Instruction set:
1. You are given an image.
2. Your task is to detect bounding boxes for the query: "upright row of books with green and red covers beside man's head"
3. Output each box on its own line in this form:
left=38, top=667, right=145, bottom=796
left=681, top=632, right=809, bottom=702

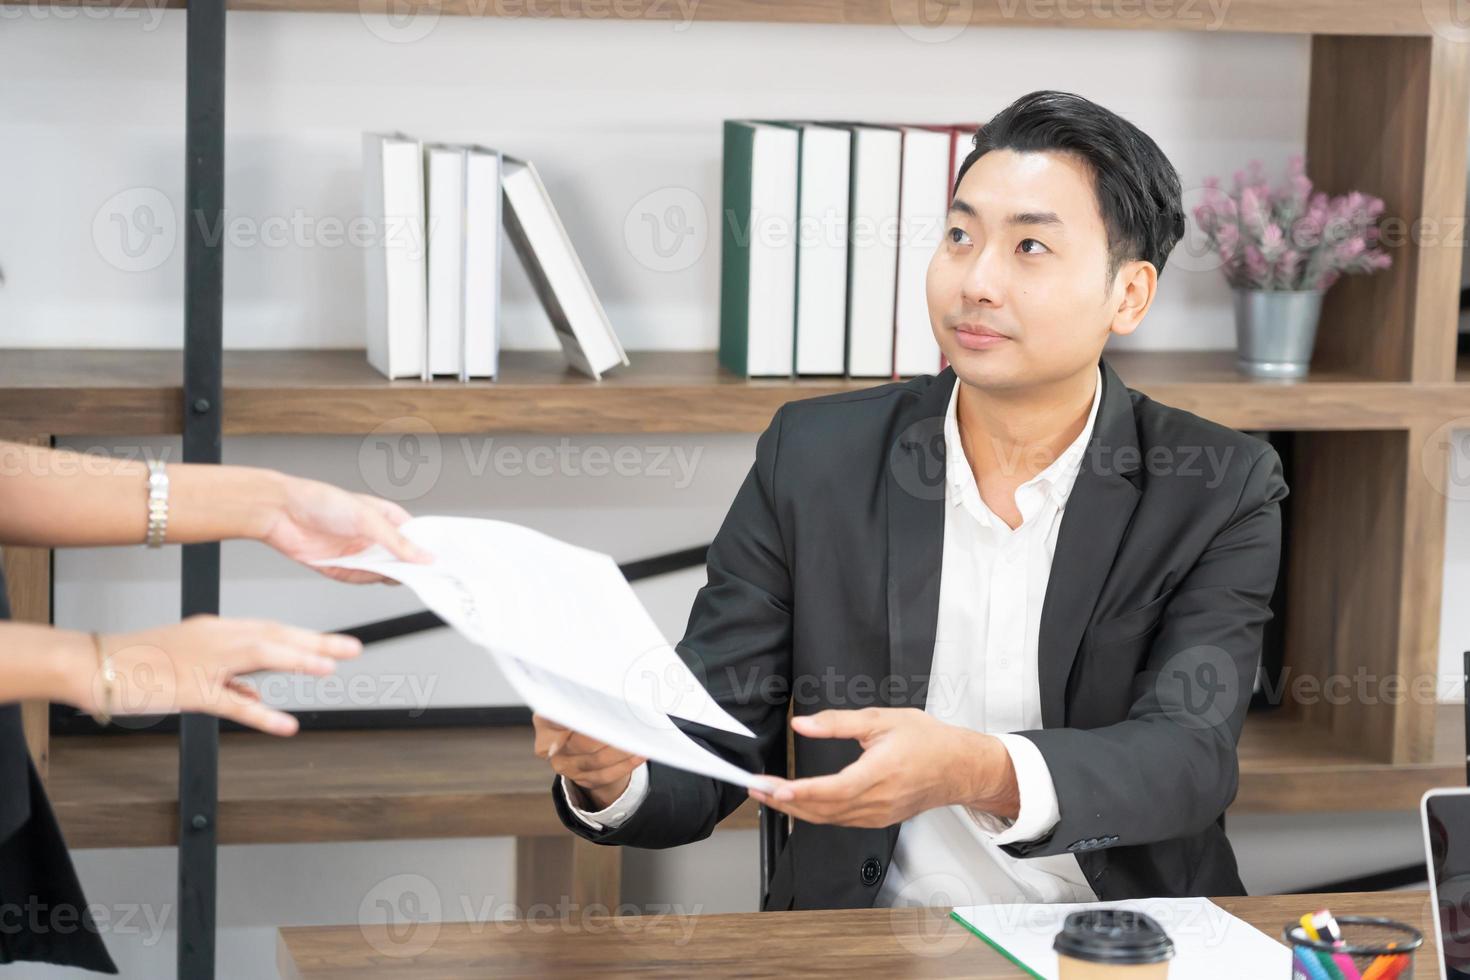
left=720, top=119, right=978, bottom=378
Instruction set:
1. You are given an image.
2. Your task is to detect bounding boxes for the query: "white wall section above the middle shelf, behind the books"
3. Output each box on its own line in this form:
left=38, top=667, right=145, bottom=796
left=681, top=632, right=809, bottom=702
left=0, top=7, right=1307, bottom=350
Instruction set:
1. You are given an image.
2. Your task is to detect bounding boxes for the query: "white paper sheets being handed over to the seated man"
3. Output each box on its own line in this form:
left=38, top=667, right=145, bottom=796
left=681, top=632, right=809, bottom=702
left=313, top=517, right=764, bottom=788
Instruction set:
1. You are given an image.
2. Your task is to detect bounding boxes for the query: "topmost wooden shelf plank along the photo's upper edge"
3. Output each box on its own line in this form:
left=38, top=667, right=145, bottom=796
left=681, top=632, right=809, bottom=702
left=3, top=0, right=1454, bottom=35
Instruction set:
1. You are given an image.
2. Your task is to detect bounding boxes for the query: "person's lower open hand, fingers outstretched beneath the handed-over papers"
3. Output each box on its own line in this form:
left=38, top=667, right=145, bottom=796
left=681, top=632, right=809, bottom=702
left=68, top=616, right=362, bottom=735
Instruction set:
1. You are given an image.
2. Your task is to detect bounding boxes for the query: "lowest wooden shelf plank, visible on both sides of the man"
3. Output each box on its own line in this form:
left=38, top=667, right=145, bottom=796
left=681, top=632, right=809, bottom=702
left=49, top=705, right=1466, bottom=848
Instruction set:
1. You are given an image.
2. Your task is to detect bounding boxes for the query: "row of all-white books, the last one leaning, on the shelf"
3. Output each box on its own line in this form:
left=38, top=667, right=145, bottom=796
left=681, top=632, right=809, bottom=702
left=363, top=132, right=628, bottom=381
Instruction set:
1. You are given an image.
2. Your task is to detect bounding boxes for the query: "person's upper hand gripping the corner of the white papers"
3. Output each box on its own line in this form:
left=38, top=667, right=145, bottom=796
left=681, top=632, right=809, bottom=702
left=256, top=473, right=434, bottom=582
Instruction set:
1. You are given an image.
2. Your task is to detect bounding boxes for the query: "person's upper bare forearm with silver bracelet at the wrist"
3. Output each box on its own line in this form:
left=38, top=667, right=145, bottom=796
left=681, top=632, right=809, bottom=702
left=0, top=442, right=282, bottom=548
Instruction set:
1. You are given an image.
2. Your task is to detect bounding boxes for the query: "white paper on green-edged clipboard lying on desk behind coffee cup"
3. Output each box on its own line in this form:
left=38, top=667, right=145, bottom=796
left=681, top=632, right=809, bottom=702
left=954, top=898, right=1291, bottom=980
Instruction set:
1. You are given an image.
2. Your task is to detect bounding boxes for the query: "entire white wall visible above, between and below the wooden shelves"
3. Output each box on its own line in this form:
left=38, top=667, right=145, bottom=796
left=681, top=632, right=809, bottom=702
left=0, top=7, right=1470, bottom=977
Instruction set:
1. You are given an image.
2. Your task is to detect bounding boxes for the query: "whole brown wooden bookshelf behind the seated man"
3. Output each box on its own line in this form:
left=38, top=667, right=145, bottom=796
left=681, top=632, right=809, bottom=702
left=0, top=0, right=1470, bottom=922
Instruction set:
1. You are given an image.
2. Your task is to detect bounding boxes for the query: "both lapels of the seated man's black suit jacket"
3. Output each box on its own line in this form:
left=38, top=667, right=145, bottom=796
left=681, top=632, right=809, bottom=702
left=885, top=360, right=1141, bottom=729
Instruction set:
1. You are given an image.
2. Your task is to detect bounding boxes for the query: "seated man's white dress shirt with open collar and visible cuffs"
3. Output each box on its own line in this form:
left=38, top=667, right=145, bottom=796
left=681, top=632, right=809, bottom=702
left=562, top=367, right=1103, bottom=905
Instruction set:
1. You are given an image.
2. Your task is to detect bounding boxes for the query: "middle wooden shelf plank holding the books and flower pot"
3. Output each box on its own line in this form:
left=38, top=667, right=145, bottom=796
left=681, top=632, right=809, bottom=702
left=0, top=350, right=1470, bottom=436
